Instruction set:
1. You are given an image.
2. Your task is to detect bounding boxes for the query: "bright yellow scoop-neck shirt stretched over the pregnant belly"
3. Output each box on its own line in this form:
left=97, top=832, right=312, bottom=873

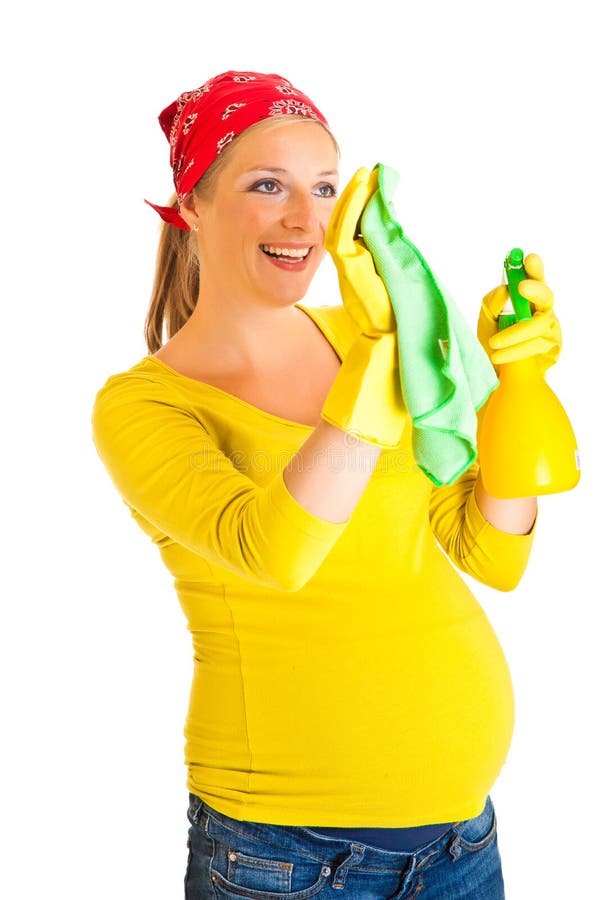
left=92, top=306, right=532, bottom=828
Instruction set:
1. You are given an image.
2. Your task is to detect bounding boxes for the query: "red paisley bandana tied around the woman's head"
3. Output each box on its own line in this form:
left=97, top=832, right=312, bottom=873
left=146, top=72, right=328, bottom=231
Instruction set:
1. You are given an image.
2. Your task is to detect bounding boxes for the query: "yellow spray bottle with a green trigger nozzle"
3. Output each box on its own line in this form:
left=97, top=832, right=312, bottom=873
left=478, top=248, right=580, bottom=499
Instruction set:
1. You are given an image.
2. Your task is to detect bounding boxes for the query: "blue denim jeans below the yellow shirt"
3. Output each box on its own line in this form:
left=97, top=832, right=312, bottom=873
left=184, top=795, right=504, bottom=900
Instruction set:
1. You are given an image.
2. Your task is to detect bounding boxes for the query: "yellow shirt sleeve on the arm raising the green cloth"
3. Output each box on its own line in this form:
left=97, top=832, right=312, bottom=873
left=92, top=373, right=347, bottom=591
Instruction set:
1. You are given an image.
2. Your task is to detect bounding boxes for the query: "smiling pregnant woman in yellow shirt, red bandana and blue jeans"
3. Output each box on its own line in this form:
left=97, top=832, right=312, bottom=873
left=93, top=72, right=552, bottom=900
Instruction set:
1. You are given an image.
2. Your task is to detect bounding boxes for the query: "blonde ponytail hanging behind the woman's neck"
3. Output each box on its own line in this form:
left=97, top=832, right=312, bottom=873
left=144, top=194, right=199, bottom=353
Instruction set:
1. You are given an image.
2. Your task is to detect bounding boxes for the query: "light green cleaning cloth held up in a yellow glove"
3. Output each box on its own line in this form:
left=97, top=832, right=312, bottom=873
left=360, top=163, right=498, bottom=485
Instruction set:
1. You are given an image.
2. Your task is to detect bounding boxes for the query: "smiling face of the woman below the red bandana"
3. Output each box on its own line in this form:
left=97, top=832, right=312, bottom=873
left=185, top=119, right=338, bottom=306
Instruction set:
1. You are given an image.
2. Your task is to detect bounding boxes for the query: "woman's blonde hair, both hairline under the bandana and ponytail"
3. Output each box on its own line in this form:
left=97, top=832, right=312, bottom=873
left=144, top=116, right=339, bottom=353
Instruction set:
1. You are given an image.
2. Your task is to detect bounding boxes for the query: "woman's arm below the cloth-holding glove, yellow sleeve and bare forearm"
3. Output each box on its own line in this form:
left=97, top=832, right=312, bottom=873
left=92, top=372, right=390, bottom=591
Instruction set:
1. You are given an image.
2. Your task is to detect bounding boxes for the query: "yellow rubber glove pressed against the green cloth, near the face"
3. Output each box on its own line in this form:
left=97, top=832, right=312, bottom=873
left=322, top=168, right=407, bottom=449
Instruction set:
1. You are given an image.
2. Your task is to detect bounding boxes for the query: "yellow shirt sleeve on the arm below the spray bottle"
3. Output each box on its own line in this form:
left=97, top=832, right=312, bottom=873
left=430, top=464, right=535, bottom=591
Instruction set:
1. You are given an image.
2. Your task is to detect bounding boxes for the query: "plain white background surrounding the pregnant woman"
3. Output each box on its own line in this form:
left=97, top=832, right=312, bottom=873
left=0, top=0, right=610, bottom=900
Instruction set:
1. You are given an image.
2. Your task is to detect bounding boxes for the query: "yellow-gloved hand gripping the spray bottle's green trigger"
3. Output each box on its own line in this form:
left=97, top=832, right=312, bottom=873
left=477, top=253, right=561, bottom=371
